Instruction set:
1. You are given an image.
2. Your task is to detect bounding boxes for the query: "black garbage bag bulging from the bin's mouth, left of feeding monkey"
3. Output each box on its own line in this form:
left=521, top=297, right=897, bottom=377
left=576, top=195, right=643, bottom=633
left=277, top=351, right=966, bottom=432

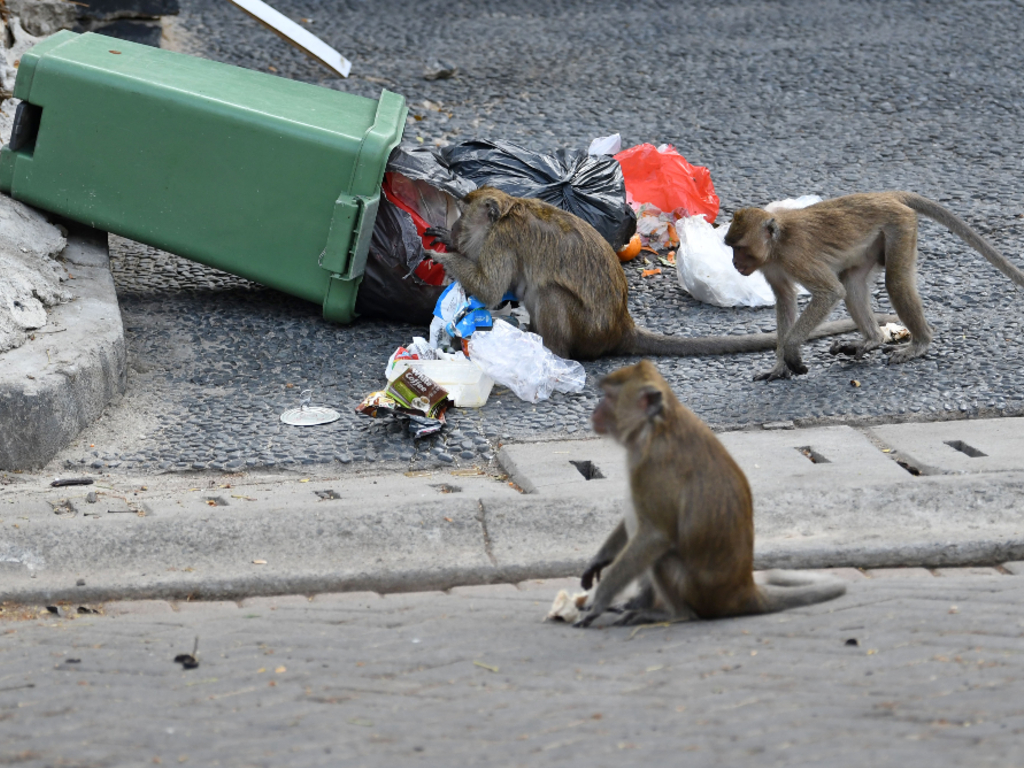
left=355, top=198, right=444, bottom=326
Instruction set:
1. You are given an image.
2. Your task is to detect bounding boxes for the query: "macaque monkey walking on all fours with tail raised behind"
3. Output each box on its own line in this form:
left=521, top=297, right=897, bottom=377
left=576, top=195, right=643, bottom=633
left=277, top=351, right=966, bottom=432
left=725, top=191, right=1024, bottom=381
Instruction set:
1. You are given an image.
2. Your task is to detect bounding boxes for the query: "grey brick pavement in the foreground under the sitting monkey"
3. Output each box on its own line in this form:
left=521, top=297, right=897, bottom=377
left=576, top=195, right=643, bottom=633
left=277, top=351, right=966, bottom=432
left=0, top=566, right=1024, bottom=768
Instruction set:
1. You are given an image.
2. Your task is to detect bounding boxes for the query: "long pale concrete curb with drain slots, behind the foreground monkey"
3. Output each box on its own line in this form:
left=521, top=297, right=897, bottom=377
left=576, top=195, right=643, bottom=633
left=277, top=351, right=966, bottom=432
left=6, top=419, right=1024, bottom=603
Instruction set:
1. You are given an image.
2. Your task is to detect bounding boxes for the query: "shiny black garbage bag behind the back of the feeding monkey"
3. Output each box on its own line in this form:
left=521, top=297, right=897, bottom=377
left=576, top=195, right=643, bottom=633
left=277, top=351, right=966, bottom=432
left=439, top=139, right=637, bottom=251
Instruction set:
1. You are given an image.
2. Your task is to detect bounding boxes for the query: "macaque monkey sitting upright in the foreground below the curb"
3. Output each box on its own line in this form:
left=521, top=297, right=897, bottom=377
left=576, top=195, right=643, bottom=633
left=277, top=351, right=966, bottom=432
left=575, top=360, right=846, bottom=627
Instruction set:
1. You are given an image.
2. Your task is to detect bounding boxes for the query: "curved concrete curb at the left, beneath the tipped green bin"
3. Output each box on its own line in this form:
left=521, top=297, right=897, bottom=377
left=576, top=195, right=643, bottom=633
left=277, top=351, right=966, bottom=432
left=0, top=228, right=126, bottom=470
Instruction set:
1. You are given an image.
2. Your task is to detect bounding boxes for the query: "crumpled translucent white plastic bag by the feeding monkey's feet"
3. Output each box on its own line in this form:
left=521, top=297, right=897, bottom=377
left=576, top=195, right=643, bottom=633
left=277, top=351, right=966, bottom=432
left=469, top=321, right=587, bottom=402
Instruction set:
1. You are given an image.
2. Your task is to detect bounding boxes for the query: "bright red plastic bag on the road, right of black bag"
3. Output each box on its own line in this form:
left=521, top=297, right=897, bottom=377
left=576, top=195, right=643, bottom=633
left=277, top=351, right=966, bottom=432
left=615, top=144, right=719, bottom=223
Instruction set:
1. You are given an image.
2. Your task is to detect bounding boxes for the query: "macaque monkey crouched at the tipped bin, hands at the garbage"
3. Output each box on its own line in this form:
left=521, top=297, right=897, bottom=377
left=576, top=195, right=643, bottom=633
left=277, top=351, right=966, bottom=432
left=427, top=186, right=886, bottom=359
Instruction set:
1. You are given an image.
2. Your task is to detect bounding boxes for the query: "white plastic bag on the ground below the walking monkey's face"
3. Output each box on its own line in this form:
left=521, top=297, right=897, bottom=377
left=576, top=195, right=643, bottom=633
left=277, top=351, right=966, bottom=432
left=676, top=216, right=775, bottom=306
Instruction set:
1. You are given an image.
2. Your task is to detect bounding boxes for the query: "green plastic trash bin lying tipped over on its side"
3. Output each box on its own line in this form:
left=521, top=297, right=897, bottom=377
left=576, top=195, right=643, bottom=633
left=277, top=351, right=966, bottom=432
left=0, top=32, right=408, bottom=323
